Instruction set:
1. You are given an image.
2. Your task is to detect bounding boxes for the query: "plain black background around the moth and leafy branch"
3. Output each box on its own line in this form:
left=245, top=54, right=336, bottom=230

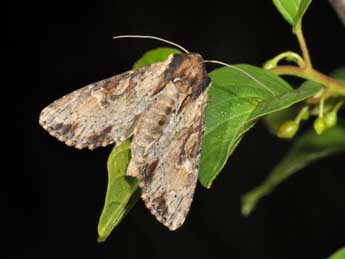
left=8, top=0, right=345, bottom=259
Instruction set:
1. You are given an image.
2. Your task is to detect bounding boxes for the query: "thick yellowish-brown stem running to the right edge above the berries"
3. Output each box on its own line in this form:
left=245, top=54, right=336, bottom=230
left=271, top=66, right=345, bottom=96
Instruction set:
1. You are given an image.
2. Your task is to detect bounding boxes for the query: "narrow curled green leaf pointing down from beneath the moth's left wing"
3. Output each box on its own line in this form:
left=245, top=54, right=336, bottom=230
left=98, top=140, right=140, bottom=242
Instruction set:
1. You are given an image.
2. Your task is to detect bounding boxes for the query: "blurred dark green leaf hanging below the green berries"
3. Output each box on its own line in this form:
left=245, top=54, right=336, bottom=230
left=242, top=125, right=345, bottom=215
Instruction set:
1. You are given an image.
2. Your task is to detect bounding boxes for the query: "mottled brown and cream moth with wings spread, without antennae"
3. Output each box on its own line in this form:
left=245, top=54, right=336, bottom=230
left=39, top=35, right=211, bottom=230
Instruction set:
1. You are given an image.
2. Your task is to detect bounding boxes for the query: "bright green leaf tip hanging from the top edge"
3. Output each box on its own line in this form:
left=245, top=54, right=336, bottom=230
left=273, top=0, right=311, bottom=28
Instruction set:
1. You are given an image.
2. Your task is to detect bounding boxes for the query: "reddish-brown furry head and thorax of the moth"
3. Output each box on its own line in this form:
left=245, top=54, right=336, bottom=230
left=168, top=53, right=211, bottom=97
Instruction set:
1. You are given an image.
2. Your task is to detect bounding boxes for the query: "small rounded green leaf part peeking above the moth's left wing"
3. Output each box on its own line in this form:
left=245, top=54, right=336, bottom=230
left=133, top=48, right=181, bottom=68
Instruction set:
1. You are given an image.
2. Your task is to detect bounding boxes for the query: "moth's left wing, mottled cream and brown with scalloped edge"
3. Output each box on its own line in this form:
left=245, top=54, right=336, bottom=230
left=39, top=57, right=172, bottom=149
